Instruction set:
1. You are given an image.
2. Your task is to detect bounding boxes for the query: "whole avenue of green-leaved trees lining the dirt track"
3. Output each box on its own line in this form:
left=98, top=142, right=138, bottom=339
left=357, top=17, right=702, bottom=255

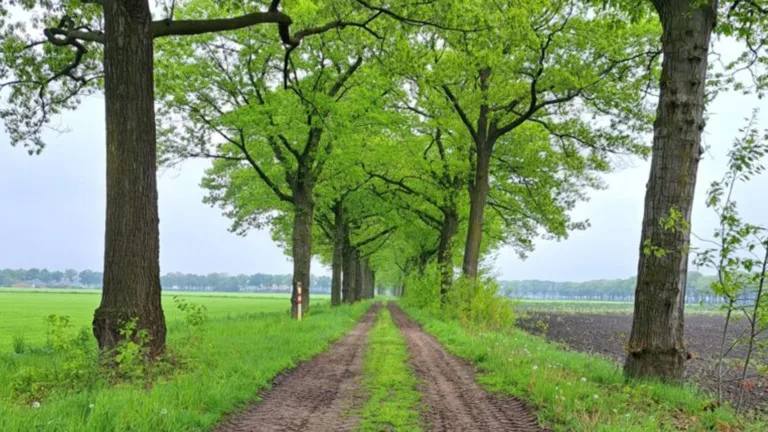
left=0, top=0, right=768, bottom=381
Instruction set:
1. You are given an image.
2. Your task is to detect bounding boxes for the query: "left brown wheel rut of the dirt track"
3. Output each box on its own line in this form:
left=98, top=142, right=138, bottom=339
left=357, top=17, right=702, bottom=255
left=216, top=304, right=381, bottom=432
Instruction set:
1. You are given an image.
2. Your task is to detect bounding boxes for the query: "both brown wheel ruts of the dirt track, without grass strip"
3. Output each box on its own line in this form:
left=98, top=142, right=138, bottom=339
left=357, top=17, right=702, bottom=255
left=217, top=303, right=542, bottom=432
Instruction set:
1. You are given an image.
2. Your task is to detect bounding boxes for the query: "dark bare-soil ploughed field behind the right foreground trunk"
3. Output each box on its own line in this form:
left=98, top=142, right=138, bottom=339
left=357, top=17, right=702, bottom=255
left=518, top=312, right=768, bottom=412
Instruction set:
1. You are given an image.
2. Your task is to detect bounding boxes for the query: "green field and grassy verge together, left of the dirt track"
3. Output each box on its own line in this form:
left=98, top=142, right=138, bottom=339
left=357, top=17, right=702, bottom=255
left=0, top=291, right=370, bottom=432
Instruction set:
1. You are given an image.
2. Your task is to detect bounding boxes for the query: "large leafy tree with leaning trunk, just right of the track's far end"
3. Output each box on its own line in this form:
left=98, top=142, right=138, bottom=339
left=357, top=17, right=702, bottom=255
left=380, top=1, right=656, bottom=278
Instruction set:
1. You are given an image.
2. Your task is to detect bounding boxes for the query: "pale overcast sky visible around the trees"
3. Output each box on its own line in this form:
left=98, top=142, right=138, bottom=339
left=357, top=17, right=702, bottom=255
left=0, top=44, right=768, bottom=281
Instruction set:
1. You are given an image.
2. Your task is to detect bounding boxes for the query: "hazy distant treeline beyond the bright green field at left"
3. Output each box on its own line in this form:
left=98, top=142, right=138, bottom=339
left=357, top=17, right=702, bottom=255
left=0, top=268, right=331, bottom=293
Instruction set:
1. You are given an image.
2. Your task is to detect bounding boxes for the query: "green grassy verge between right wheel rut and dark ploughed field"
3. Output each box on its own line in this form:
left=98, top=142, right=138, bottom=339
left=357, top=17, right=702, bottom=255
left=405, top=306, right=768, bottom=432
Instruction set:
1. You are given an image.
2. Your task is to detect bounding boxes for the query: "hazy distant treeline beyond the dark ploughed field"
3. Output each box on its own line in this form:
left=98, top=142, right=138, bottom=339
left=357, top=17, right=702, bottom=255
left=499, top=272, right=720, bottom=303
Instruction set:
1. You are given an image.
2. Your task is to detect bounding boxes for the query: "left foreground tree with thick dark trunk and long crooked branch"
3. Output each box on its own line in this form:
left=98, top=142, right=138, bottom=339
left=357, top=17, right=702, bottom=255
left=0, top=0, right=402, bottom=356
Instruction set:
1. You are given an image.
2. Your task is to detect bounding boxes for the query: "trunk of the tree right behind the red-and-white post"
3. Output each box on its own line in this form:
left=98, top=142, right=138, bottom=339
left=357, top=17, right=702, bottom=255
left=291, top=186, right=314, bottom=317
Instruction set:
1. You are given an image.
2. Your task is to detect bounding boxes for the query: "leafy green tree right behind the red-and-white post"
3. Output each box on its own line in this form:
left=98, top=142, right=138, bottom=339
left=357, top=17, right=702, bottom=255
left=154, top=6, right=390, bottom=314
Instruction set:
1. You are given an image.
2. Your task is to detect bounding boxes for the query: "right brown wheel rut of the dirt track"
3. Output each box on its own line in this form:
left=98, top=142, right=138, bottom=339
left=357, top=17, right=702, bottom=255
left=389, top=303, right=542, bottom=432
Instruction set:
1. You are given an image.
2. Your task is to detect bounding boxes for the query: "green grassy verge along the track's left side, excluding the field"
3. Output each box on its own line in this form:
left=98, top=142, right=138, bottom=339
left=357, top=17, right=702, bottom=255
left=0, top=296, right=370, bottom=432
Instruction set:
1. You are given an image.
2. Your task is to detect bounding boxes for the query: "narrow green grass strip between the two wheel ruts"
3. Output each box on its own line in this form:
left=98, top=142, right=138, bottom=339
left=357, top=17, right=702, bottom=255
left=360, top=307, right=421, bottom=431
